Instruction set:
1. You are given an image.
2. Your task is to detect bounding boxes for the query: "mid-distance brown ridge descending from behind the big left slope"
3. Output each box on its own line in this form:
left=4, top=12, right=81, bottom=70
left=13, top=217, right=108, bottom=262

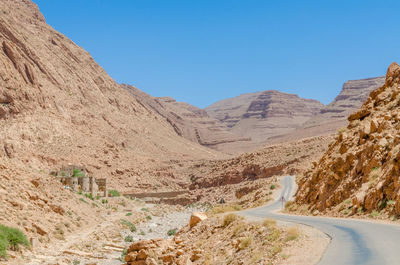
left=122, top=85, right=250, bottom=149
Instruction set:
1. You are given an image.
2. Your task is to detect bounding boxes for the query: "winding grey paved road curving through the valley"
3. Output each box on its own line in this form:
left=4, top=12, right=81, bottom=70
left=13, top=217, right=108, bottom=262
left=242, top=176, right=400, bottom=265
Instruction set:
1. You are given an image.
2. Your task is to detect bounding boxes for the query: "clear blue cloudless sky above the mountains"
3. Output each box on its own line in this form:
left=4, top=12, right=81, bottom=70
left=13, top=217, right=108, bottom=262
left=34, top=0, right=400, bottom=107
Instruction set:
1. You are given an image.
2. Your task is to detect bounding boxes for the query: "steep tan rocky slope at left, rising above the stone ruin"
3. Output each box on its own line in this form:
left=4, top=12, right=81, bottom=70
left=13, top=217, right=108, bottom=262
left=0, top=0, right=222, bottom=191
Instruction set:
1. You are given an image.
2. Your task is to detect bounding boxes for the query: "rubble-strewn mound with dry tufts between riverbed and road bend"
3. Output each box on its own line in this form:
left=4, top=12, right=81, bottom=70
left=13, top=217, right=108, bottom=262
left=125, top=213, right=328, bottom=265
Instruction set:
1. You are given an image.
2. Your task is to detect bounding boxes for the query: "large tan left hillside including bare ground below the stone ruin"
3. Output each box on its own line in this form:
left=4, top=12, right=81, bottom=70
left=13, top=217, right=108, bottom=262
left=0, top=0, right=227, bottom=250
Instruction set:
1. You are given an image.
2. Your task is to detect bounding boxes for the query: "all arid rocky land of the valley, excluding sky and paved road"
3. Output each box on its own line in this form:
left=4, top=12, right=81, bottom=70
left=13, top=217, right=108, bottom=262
left=0, top=0, right=400, bottom=265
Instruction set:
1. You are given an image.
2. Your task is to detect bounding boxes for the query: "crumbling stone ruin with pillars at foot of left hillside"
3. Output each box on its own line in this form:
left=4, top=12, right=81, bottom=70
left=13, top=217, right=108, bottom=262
left=54, top=165, right=107, bottom=197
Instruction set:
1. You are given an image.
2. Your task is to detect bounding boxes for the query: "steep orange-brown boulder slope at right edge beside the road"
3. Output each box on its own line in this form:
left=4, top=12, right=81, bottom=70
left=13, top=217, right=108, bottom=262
left=296, top=63, right=400, bottom=215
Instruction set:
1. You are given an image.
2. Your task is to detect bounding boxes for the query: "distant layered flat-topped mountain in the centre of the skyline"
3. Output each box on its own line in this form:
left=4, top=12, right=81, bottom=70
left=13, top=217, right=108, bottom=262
left=205, top=90, right=324, bottom=143
